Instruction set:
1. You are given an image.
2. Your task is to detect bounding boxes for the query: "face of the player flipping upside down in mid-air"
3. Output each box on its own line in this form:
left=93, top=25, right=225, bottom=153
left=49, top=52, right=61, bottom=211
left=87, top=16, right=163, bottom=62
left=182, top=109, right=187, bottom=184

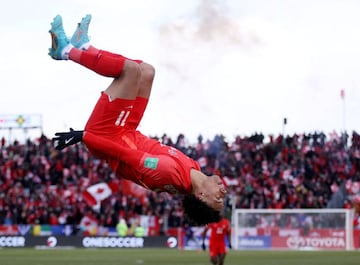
left=204, top=175, right=226, bottom=211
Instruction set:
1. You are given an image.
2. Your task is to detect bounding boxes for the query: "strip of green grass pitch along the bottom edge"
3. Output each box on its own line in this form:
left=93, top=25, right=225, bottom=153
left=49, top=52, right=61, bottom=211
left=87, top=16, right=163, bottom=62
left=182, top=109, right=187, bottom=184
left=0, top=248, right=360, bottom=265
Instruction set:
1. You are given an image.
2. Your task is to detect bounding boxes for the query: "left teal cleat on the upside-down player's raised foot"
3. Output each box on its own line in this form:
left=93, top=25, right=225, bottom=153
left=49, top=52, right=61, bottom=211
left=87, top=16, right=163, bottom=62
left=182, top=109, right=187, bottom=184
left=49, top=15, right=69, bottom=60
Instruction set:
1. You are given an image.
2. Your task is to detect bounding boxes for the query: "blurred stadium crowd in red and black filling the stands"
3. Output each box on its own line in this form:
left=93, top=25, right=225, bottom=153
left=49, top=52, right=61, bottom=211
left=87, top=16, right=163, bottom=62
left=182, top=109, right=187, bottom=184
left=0, top=132, right=360, bottom=234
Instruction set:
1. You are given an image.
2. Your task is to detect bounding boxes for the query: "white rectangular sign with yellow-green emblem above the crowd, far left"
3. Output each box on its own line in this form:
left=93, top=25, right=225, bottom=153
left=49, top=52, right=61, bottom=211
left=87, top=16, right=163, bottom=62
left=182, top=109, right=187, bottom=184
left=0, top=114, right=42, bottom=129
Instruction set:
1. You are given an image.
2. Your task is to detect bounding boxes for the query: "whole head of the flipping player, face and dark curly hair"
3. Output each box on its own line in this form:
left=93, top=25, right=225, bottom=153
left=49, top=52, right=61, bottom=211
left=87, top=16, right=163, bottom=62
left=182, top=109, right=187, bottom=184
left=183, top=175, right=226, bottom=225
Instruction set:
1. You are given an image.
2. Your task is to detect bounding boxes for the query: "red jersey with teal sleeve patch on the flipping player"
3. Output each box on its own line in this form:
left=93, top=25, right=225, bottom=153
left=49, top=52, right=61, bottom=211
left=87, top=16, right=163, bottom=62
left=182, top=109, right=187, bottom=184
left=83, top=131, right=200, bottom=194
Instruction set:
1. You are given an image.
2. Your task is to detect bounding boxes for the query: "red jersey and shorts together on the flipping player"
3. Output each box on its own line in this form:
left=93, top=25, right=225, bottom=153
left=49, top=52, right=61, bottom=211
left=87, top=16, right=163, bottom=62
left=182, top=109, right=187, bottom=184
left=83, top=92, right=200, bottom=194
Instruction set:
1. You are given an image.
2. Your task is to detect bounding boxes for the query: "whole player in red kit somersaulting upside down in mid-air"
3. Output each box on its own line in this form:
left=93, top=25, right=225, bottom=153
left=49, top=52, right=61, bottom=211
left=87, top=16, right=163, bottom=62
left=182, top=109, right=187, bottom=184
left=49, top=15, right=226, bottom=225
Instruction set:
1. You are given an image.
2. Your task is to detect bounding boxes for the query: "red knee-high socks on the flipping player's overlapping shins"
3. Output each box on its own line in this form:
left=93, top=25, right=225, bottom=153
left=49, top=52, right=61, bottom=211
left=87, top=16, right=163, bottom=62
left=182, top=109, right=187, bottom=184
left=69, top=48, right=127, bottom=77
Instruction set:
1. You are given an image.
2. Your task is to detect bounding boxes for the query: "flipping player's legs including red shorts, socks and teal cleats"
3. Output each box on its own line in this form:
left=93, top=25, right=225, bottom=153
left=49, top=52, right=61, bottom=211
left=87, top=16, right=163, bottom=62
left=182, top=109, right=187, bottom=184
left=49, top=15, right=155, bottom=135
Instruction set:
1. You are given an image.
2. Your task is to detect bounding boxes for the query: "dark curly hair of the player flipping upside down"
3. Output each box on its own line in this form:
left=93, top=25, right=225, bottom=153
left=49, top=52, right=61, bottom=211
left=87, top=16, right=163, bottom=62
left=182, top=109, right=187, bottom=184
left=182, top=194, right=221, bottom=226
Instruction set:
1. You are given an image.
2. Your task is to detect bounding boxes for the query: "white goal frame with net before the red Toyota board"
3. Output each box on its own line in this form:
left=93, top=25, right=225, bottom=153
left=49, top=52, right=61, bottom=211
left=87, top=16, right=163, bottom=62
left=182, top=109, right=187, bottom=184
left=232, top=209, right=354, bottom=250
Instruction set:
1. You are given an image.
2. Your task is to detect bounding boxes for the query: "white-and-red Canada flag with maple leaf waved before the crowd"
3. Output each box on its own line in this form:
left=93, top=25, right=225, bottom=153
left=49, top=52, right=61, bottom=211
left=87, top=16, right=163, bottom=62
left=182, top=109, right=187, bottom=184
left=82, top=182, right=119, bottom=210
